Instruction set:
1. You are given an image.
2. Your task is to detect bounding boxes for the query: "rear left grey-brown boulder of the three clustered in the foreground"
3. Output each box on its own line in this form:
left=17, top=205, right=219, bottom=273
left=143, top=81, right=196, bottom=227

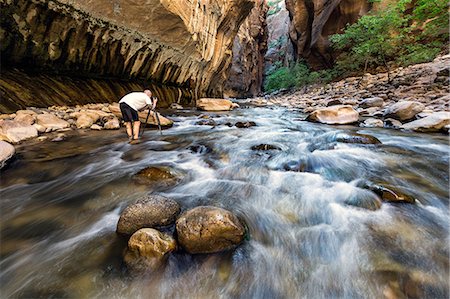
left=117, top=195, right=180, bottom=235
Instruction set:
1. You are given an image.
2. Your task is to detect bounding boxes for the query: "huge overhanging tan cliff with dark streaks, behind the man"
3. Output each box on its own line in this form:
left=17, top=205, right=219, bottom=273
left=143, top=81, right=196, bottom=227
left=0, top=0, right=253, bottom=112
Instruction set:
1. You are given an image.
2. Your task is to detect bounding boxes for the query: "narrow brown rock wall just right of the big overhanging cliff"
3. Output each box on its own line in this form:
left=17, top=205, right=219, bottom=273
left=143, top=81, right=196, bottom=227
left=224, top=0, right=268, bottom=98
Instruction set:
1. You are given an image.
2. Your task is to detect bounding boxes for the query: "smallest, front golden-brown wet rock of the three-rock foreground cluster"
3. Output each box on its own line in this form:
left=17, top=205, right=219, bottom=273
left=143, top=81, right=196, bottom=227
left=124, top=228, right=177, bottom=272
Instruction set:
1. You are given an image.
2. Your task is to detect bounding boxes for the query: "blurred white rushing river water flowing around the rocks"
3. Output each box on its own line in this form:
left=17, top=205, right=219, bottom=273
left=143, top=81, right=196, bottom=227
left=0, top=107, right=450, bottom=298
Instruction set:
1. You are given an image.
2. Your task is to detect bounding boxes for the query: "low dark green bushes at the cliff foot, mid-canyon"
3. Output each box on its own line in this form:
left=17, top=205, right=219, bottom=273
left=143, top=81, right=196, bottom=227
left=264, top=61, right=337, bottom=92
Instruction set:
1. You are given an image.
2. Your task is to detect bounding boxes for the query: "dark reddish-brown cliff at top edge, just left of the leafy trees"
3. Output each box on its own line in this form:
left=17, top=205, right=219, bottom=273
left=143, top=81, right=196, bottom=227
left=286, top=0, right=372, bottom=69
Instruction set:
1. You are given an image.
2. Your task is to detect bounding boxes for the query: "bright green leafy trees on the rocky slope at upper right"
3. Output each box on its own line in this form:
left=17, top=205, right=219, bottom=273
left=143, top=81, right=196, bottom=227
left=330, top=0, right=448, bottom=72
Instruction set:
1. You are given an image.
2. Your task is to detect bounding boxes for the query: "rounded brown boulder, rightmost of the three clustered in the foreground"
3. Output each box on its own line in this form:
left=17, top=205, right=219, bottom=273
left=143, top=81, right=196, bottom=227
left=176, top=206, right=245, bottom=253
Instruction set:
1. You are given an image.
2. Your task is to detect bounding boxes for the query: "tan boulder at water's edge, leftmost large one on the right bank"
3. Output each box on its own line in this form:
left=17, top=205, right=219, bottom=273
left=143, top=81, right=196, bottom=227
left=306, top=105, right=359, bottom=125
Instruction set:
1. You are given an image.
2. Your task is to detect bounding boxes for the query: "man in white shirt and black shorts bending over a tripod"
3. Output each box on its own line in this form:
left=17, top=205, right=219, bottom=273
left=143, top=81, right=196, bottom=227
left=119, top=89, right=158, bottom=143
